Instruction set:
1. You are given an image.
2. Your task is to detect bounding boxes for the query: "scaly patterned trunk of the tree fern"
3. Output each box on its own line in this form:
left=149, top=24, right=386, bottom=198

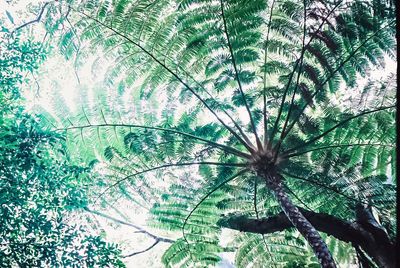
left=266, top=174, right=336, bottom=268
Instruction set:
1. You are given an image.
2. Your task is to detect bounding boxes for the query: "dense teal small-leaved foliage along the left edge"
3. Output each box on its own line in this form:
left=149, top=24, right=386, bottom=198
left=0, top=27, right=124, bottom=267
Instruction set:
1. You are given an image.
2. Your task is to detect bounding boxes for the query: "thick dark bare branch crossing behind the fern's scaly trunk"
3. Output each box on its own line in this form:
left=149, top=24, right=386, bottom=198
left=217, top=208, right=396, bottom=267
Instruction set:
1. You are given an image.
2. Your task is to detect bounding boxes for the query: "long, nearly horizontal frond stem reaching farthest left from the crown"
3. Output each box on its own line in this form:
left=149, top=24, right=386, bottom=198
left=56, top=124, right=251, bottom=159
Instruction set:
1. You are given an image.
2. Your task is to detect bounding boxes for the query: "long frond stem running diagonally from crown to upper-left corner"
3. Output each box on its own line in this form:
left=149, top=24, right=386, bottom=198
left=75, top=7, right=253, bottom=152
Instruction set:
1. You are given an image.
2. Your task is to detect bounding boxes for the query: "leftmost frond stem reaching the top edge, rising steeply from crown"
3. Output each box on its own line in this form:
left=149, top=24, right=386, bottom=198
left=220, top=0, right=262, bottom=150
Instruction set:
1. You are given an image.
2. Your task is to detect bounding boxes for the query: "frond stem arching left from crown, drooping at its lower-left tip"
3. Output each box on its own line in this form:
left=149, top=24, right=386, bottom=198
left=95, top=162, right=247, bottom=202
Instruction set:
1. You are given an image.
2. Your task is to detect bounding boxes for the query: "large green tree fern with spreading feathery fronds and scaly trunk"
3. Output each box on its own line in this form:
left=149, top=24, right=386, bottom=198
left=36, top=0, right=395, bottom=267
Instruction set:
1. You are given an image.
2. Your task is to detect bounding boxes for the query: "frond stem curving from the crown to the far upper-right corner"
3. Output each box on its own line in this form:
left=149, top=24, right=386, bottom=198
left=282, top=21, right=395, bottom=142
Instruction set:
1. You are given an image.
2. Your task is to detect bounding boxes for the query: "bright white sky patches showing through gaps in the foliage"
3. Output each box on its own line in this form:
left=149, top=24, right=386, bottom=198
left=0, top=0, right=396, bottom=267
